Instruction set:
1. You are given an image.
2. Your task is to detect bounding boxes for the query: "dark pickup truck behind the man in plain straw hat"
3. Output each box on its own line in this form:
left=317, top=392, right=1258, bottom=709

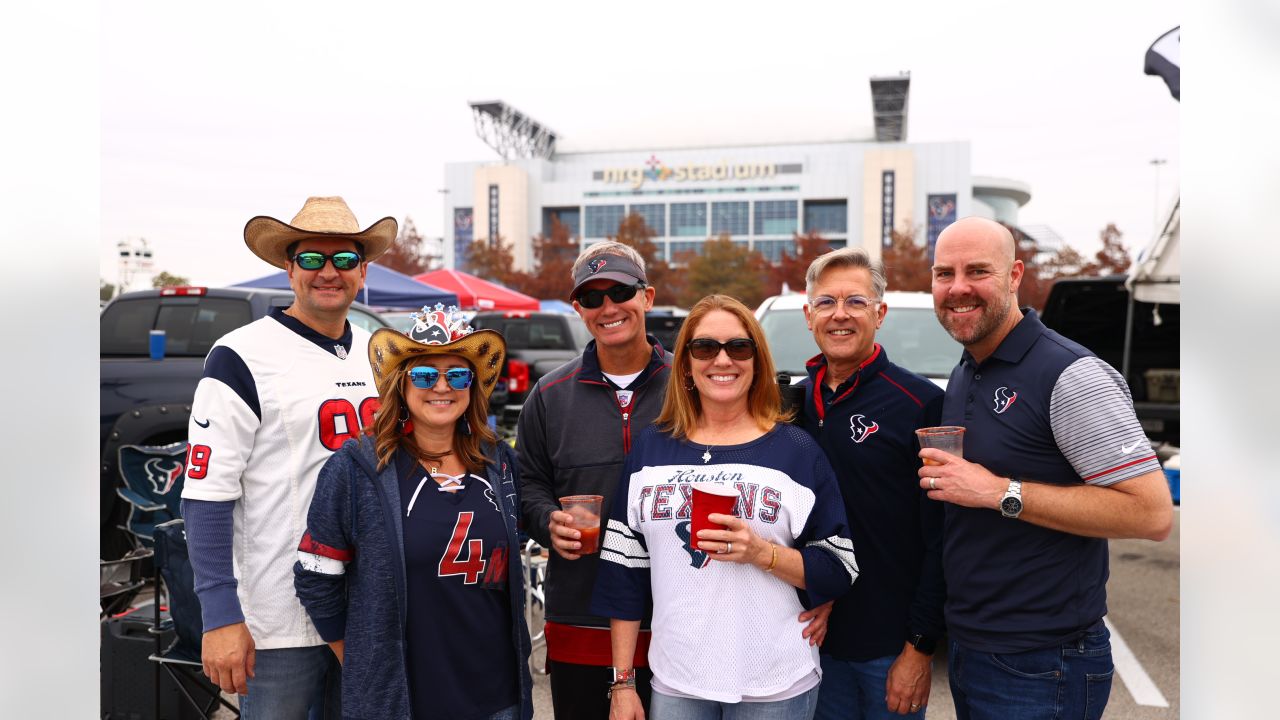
left=99, top=287, right=387, bottom=559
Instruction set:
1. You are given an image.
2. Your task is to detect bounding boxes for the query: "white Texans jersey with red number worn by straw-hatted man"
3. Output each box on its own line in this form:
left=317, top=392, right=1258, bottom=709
left=182, top=313, right=379, bottom=650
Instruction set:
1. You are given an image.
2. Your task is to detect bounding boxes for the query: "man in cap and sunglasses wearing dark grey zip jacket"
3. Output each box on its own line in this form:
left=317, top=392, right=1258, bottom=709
left=516, top=241, right=672, bottom=720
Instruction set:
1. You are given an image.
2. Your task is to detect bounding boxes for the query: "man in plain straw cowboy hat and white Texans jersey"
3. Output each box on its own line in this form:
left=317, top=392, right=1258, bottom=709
left=182, top=197, right=397, bottom=720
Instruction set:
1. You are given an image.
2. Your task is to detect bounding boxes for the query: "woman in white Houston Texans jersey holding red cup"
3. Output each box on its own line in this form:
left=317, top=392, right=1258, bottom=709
left=591, top=295, right=858, bottom=720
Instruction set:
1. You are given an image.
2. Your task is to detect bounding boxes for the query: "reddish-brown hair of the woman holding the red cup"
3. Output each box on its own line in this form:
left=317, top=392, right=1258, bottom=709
left=654, top=295, right=791, bottom=438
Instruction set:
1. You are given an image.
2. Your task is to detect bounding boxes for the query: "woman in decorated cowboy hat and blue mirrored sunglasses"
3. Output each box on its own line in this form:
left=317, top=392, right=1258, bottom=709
left=294, top=305, right=532, bottom=720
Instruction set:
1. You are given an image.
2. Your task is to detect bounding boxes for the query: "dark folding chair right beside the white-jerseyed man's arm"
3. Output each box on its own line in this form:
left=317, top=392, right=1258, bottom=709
left=148, top=519, right=239, bottom=720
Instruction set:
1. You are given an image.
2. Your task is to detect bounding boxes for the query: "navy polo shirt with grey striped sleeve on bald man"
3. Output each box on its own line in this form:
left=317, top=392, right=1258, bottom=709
left=942, top=309, right=1160, bottom=652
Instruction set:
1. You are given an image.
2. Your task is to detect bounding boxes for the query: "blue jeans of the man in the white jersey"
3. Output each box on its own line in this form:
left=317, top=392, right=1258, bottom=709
left=239, top=644, right=342, bottom=720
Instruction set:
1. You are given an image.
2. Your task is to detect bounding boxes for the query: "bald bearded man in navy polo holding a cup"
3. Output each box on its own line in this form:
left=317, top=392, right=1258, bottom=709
left=920, top=218, right=1172, bottom=720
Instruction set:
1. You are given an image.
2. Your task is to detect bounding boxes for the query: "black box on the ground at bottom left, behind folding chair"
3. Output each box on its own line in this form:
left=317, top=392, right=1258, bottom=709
left=100, top=605, right=220, bottom=720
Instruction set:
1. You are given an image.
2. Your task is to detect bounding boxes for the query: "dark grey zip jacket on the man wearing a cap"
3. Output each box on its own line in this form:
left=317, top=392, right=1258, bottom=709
left=516, top=336, right=672, bottom=628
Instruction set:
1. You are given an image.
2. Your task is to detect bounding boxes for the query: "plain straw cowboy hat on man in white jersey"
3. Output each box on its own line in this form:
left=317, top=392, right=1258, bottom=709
left=244, top=197, right=398, bottom=268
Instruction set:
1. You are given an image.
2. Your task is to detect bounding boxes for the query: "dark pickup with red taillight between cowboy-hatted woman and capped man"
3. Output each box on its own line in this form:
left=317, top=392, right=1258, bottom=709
left=471, top=310, right=591, bottom=425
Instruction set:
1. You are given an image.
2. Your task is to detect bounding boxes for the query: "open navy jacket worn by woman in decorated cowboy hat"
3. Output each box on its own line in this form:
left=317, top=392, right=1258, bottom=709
left=293, top=436, right=534, bottom=720
